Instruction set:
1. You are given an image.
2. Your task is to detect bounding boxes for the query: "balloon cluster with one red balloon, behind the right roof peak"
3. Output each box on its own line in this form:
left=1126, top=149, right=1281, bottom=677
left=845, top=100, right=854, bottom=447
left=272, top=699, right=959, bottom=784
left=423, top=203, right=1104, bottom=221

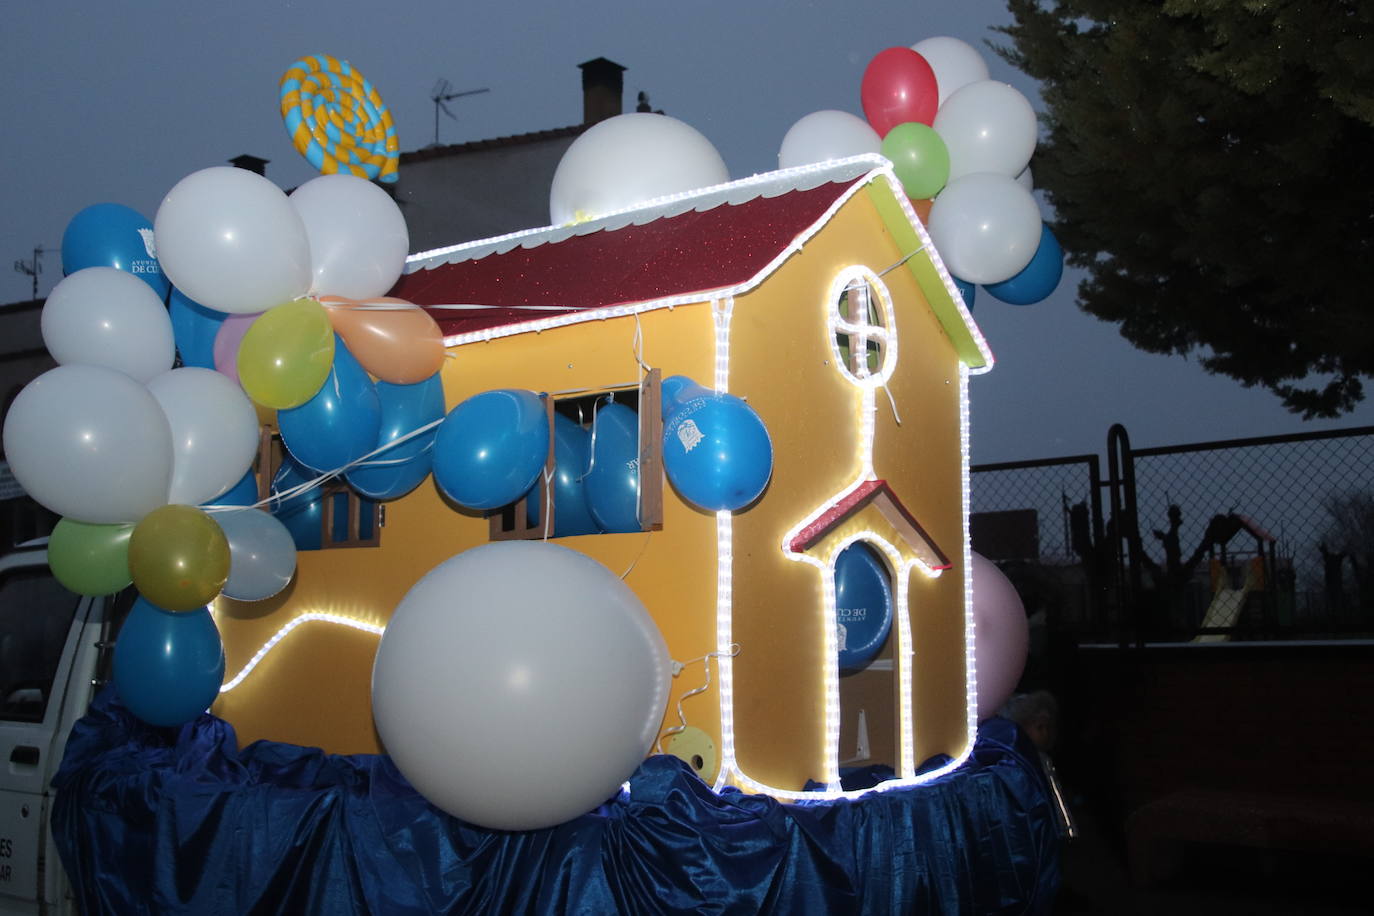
left=779, top=36, right=1063, bottom=305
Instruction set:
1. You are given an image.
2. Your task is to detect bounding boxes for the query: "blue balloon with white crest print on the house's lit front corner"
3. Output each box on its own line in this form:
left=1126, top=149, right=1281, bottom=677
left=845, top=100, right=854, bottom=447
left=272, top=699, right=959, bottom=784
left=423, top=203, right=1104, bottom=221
left=662, top=375, right=772, bottom=511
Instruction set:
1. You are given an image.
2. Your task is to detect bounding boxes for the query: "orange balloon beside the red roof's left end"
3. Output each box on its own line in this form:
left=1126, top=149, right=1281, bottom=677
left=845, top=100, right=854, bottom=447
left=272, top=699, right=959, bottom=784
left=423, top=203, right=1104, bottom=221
left=320, top=295, right=444, bottom=385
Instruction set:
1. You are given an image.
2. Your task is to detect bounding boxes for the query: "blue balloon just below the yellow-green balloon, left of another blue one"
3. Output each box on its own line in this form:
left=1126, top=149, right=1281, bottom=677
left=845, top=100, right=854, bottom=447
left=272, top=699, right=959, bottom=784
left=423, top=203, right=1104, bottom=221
left=276, top=335, right=382, bottom=472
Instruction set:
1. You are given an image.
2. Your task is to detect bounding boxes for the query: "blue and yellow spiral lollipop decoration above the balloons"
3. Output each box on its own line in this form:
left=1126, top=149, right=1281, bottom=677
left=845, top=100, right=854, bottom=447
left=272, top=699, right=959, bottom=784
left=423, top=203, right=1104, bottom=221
left=282, top=54, right=400, bottom=183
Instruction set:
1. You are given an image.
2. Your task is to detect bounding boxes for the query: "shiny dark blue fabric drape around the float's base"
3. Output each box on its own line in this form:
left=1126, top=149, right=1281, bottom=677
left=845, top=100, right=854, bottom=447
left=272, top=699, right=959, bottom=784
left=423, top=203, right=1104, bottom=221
left=54, top=691, right=1059, bottom=916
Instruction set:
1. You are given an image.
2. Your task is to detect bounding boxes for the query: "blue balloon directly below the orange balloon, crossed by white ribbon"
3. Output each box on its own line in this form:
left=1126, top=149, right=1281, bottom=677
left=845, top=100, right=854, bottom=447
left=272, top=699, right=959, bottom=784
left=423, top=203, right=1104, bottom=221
left=344, top=372, right=444, bottom=500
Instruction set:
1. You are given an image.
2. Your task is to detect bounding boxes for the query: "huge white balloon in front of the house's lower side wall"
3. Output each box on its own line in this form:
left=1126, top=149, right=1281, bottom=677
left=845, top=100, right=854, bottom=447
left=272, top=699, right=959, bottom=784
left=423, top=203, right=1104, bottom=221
left=372, top=541, right=671, bottom=829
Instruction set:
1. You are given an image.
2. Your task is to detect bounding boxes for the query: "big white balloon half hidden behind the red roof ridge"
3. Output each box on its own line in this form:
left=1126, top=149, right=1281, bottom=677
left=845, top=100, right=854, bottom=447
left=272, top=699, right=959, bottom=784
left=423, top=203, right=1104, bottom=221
left=548, top=111, right=730, bottom=225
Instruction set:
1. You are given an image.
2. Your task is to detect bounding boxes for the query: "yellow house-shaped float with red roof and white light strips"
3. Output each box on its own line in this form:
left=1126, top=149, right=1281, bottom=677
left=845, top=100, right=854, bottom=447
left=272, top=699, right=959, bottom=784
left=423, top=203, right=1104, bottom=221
left=208, top=157, right=992, bottom=797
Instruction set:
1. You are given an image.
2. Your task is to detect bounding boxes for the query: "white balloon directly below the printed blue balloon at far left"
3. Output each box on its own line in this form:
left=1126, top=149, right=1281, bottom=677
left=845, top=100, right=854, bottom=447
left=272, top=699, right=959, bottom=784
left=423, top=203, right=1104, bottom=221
left=40, top=268, right=176, bottom=382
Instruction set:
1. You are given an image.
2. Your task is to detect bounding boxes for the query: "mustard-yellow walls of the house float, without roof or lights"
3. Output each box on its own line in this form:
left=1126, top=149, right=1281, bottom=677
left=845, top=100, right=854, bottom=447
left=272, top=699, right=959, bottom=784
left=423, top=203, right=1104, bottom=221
left=214, top=181, right=971, bottom=788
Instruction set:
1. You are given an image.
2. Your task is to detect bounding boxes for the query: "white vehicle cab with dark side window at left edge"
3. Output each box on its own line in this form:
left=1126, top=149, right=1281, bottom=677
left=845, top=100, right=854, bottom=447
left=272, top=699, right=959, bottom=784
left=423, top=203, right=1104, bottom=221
left=0, top=538, right=126, bottom=916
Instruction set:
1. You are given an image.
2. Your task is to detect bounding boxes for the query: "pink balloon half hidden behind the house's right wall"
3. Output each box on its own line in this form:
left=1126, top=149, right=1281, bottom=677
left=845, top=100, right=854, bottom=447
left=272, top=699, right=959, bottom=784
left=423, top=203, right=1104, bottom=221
left=971, top=553, right=1031, bottom=722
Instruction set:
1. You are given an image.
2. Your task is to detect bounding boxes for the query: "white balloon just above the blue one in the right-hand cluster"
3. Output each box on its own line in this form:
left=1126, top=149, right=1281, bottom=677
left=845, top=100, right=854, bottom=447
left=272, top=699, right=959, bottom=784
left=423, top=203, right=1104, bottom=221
left=926, top=172, right=1040, bottom=284
